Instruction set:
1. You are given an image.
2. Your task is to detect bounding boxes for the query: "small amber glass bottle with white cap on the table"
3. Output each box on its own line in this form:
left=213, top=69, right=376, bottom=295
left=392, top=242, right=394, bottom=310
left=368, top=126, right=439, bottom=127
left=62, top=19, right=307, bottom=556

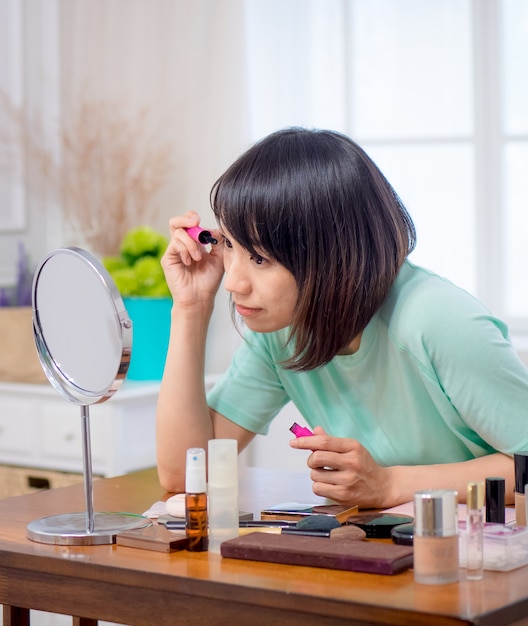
left=185, top=448, right=209, bottom=552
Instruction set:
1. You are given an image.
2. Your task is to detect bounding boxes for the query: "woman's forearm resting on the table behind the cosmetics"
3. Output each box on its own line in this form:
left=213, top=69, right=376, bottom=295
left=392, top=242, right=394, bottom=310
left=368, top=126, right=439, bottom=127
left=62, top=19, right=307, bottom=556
left=387, top=453, right=514, bottom=506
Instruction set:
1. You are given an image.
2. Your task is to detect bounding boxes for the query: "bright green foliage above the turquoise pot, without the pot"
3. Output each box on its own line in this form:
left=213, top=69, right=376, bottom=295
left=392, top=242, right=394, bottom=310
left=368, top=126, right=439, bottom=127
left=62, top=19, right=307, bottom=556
left=103, top=226, right=170, bottom=298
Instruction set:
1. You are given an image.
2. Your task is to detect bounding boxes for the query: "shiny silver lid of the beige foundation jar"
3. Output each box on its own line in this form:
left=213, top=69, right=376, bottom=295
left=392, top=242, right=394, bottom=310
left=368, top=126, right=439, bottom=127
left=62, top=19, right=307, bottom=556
left=414, top=489, right=458, bottom=537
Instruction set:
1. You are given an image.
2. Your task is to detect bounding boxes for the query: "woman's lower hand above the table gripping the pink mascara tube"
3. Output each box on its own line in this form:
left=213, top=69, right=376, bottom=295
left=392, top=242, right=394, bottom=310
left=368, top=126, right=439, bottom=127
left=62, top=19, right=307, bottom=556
left=290, top=426, right=393, bottom=509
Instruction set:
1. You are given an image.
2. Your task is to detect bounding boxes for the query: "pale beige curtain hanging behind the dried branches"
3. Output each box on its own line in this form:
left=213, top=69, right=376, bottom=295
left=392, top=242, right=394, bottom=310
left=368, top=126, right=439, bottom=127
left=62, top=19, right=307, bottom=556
left=60, top=0, right=253, bottom=241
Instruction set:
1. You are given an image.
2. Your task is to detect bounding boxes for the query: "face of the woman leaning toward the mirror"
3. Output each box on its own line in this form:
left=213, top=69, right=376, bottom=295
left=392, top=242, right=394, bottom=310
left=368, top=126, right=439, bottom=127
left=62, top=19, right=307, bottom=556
left=223, top=228, right=298, bottom=333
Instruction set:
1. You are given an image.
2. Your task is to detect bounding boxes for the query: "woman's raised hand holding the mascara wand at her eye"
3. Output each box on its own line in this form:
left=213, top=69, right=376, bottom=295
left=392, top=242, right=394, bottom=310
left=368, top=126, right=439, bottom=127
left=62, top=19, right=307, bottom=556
left=161, top=211, right=224, bottom=307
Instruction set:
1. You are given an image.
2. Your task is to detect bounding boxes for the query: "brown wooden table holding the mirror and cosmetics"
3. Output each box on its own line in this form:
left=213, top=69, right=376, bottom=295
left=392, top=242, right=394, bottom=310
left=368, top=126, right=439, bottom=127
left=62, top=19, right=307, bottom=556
left=0, top=468, right=528, bottom=626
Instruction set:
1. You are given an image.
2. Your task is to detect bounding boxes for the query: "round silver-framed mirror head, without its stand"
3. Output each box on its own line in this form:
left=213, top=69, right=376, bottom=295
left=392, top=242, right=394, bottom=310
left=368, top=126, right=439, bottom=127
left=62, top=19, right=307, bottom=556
left=33, top=248, right=132, bottom=404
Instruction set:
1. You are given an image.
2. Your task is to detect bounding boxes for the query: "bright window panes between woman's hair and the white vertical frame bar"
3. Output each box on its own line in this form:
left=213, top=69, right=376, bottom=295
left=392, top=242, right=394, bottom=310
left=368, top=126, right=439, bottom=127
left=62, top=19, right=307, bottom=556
left=347, top=0, right=476, bottom=292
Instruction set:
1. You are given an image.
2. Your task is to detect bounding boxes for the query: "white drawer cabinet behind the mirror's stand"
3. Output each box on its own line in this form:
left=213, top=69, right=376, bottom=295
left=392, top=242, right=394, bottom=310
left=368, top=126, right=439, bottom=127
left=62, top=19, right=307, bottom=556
left=0, top=381, right=159, bottom=476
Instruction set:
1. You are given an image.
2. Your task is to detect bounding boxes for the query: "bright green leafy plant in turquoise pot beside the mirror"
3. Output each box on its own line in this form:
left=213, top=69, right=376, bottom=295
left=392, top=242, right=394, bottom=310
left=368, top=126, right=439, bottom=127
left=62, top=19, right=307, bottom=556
left=103, top=226, right=172, bottom=380
